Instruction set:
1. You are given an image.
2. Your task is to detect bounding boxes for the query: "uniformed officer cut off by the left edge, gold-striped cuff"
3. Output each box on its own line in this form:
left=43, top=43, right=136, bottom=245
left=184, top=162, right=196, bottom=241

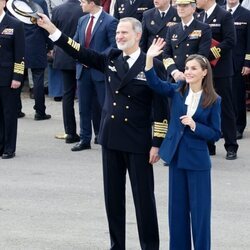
left=0, top=0, right=25, bottom=159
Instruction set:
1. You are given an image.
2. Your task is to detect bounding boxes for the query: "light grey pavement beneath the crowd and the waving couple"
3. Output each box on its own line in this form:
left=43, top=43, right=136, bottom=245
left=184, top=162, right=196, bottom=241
left=0, top=93, right=250, bottom=250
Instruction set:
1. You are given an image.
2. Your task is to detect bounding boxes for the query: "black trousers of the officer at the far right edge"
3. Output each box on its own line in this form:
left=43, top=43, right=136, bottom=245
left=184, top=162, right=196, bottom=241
left=232, top=71, right=247, bottom=133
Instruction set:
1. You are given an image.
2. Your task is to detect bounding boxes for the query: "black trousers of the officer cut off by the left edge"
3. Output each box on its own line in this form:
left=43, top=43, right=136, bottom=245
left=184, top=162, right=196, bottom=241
left=0, top=86, right=19, bottom=154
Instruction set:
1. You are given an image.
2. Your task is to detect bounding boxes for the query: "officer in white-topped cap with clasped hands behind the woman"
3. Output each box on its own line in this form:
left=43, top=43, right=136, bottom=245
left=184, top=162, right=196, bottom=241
left=163, top=0, right=212, bottom=81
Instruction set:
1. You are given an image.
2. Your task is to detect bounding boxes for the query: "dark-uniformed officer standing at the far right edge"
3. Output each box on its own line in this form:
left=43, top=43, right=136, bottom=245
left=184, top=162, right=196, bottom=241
left=226, top=0, right=250, bottom=139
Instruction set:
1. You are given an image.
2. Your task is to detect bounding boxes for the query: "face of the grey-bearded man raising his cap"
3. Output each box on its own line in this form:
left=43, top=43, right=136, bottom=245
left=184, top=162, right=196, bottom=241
left=115, top=22, right=141, bottom=51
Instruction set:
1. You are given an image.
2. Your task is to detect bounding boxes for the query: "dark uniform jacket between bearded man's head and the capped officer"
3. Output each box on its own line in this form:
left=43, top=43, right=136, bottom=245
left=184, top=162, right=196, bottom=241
left=140, top=7, right=180, bottom=52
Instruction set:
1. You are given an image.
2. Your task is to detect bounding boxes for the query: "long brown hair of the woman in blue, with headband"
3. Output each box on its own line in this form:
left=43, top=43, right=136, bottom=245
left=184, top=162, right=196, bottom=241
left=180, top=54, right=218, bottom=108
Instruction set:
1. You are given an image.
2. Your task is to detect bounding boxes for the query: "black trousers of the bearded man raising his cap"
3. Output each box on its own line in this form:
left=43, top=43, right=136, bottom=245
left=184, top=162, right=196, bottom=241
left=102, top=147, right=159, bottom=250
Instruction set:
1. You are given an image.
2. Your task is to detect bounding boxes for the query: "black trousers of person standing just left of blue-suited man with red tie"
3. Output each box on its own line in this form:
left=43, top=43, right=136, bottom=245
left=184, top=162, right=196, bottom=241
left=62, top=70, right=76, bottom=135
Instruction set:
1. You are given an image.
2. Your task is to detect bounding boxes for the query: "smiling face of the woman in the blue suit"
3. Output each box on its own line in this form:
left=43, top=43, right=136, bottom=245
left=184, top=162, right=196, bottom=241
left=184, top=59, right=207, bottom=87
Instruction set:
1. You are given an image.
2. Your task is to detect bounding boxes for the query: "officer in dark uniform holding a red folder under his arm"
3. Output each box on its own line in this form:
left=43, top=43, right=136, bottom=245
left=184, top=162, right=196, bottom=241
left=196, top=0, right=238, bottom=160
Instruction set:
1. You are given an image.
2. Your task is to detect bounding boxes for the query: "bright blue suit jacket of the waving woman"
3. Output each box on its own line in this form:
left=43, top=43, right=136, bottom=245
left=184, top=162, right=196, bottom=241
left=145, top=69, right=221, bottom=170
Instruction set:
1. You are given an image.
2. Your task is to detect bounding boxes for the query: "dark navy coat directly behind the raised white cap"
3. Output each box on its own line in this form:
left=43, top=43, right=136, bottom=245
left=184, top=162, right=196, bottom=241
left=24, top=0, right=53, bottom=68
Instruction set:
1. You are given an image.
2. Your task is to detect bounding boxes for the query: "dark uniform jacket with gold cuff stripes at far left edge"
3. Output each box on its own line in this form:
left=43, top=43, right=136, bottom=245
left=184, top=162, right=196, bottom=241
left=0, top=14, right=25, bottom=86
